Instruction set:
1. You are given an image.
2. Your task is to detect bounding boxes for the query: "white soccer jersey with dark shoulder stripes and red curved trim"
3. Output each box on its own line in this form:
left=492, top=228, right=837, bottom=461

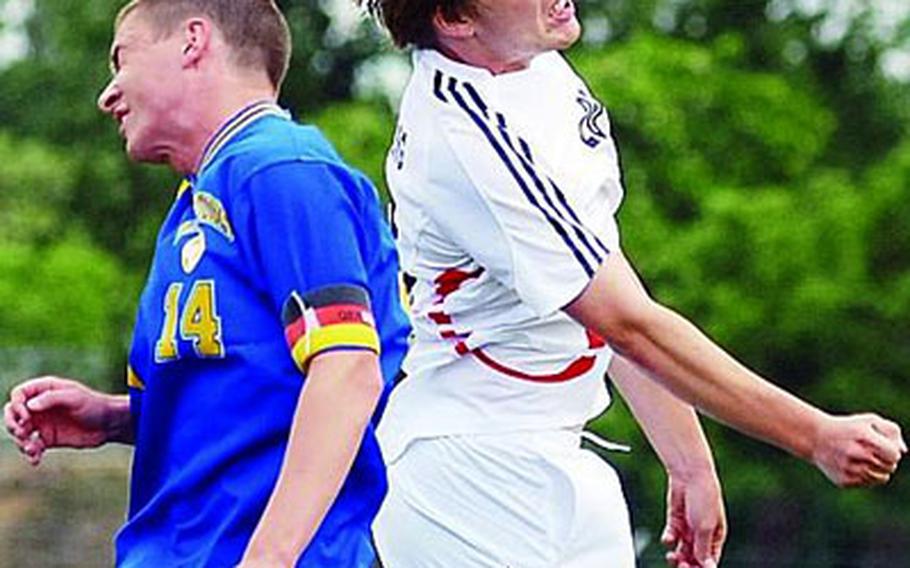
left=379, top=50, right=623, bottom=461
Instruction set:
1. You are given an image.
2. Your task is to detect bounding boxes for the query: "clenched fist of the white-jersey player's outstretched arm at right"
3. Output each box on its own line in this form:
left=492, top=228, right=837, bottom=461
left=812, top=414, right=907, bottom=487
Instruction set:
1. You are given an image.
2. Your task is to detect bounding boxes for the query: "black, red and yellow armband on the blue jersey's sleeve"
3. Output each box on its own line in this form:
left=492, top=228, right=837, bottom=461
left=281, top=285, right=379, bottom=373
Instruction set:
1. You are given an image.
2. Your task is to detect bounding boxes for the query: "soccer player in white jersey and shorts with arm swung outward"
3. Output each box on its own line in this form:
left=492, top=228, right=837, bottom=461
left=361, top=0, right=907, bottom=568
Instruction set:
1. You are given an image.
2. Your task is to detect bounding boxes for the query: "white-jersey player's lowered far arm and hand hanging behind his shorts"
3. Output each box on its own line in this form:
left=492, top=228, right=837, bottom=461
left=609, top=356, right=727, bottom=566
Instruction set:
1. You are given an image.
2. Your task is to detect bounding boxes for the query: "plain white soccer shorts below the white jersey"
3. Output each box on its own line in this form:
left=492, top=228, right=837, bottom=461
left=373, top=430, right=635, bottom=568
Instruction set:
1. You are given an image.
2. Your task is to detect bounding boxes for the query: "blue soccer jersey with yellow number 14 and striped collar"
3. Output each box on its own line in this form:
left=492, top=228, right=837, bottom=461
left=116, top=103, right=408, bottom=567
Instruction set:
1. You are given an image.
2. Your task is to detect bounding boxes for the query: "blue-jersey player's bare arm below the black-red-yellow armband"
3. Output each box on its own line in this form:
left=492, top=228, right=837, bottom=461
left=241, top=351, right=382, bottom=567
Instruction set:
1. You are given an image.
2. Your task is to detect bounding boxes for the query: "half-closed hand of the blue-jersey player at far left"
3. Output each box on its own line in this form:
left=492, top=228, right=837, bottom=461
left=3, top=377, right=129, bottom=466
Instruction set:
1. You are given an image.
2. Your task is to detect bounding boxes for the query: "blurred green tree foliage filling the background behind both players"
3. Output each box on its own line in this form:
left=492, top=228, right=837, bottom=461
left=0, top=0, right=910, bottom=567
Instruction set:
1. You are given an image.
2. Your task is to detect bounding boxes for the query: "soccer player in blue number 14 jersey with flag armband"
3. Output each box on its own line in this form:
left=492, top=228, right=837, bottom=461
left=5, top=0, right=408, bottom=567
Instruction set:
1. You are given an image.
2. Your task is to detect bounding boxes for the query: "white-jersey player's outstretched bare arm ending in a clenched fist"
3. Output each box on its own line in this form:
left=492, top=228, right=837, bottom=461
left=566, top=252, right=907, bottom=485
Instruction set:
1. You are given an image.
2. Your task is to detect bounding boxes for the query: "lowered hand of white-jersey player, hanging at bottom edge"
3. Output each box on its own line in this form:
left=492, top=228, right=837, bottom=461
left=661, top=470, right=727, bottom=568
